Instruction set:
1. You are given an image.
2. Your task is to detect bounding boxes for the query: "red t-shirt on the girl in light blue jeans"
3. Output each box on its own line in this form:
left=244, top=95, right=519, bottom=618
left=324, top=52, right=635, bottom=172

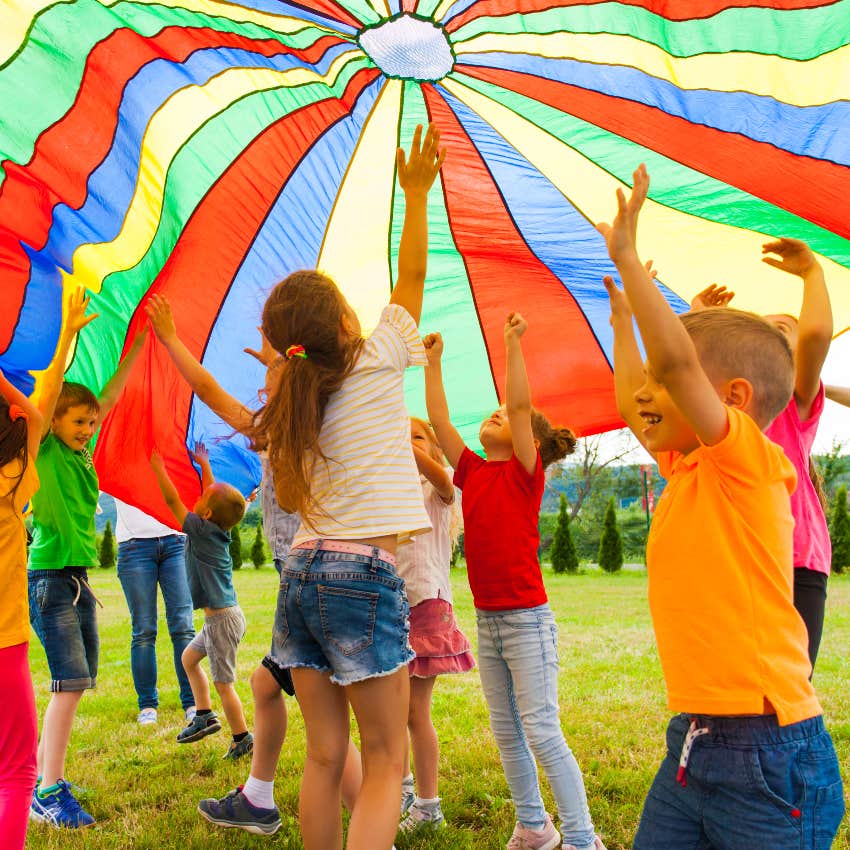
left=454, top=448, right=547, bottom=611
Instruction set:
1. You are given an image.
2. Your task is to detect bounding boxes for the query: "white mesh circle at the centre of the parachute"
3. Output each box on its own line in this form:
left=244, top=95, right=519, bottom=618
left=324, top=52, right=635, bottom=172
left=359, top=14, right=454, bottom=81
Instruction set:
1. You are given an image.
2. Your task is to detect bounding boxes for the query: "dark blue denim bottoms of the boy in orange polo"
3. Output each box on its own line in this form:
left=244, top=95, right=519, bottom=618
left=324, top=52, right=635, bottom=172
left=632, top=714, right=844, bottom=850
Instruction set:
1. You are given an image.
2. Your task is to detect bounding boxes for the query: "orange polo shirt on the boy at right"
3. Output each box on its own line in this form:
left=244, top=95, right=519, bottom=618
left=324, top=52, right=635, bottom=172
left=647, top=408, right=821, bottom=726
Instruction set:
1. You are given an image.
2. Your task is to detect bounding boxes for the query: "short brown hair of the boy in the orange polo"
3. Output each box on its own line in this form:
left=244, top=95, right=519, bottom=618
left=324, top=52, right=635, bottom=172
left=679, top=307, right=794, bottom=429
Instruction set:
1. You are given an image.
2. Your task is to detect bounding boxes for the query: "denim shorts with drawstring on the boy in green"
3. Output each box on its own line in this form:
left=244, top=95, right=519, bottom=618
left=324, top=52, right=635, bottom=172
left=27, top=567, right=100, bottom=692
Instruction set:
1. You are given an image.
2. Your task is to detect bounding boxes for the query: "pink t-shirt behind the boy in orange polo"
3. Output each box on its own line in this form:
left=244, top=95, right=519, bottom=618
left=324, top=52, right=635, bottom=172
left=764, top=384, right=832, bottom=574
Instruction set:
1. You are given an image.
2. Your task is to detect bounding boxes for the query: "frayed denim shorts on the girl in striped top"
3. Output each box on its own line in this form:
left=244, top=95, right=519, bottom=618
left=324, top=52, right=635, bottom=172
left=271, top=541, right=415, bottom=685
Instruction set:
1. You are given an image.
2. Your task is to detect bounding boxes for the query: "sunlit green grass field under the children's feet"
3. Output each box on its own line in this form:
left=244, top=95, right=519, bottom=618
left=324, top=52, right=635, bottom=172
left=27, top=567, right=850, bottom=850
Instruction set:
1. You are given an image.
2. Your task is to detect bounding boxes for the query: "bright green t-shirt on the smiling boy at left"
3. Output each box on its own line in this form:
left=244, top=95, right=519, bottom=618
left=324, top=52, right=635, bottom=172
left=29, top=433, right=98, bottom=570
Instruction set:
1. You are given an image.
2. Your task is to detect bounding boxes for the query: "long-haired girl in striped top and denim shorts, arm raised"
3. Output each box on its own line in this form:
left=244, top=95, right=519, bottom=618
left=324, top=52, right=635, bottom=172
left=240, top=121, right=444, bottom=850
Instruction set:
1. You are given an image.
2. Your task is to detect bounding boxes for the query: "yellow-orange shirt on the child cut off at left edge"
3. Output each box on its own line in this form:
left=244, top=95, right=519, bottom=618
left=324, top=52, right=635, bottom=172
left=0, top=458, right=38, bottom=649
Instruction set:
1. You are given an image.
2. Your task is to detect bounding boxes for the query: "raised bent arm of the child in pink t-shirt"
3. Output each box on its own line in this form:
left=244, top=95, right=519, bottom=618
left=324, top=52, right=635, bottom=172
left=762, top=239, right=832, bottom=422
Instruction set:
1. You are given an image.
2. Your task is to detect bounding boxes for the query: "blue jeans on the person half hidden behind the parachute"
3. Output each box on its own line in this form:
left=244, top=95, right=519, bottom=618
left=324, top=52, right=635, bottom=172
left=118, top=534, right=195, bottom=709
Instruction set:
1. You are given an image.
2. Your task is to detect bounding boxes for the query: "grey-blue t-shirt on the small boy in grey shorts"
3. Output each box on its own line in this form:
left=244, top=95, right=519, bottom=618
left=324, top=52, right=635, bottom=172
left=183, top=512, right=237, bottom=608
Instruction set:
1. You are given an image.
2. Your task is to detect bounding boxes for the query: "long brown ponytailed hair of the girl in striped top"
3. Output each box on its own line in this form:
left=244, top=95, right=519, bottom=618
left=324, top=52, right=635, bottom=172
left=249, top=271, right=363, bottom=523
